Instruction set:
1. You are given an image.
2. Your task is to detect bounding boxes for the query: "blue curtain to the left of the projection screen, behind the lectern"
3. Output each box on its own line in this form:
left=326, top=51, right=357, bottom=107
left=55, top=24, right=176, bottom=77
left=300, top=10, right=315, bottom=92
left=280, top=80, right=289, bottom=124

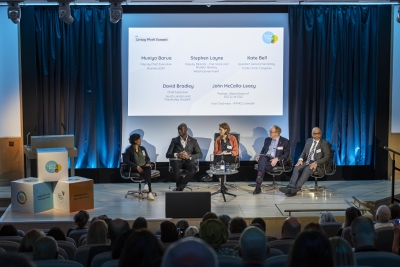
left=32, top=6, right=122, bottom=168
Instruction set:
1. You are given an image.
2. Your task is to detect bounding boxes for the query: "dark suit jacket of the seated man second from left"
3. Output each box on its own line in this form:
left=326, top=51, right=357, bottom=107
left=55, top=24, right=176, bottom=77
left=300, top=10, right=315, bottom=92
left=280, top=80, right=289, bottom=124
left=166, top=136, right=203, bottom=164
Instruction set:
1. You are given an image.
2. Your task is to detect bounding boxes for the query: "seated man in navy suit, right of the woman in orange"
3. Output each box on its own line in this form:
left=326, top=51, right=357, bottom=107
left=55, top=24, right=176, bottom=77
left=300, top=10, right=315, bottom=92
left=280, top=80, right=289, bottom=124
left=253, top=125, right=290, bottom=194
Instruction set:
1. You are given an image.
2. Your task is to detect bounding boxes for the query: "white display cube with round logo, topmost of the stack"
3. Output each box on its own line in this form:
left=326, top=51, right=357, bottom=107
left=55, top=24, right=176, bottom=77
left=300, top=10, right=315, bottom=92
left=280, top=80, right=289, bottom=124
left=36, top=147, right=68, bottom=182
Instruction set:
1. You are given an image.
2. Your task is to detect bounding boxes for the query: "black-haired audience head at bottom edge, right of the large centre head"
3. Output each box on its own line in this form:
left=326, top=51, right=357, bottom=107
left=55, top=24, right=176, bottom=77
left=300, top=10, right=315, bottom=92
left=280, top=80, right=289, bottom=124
left=287, top=230, right=334, bottom=267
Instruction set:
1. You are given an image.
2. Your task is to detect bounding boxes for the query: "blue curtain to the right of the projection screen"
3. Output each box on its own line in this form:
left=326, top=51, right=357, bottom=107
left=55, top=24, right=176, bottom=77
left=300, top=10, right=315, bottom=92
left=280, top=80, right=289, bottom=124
left=289, top=6, right=379, bottom=165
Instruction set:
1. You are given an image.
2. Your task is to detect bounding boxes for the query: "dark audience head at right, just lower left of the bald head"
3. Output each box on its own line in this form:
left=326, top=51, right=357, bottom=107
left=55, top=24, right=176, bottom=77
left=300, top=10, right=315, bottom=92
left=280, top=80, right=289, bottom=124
left=351, top=216, right=378, bottom=252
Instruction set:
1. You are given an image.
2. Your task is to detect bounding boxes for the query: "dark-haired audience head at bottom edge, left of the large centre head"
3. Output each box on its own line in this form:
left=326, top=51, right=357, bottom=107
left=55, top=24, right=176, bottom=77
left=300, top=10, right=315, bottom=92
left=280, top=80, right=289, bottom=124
left=119, top=229, right=164, bottom=267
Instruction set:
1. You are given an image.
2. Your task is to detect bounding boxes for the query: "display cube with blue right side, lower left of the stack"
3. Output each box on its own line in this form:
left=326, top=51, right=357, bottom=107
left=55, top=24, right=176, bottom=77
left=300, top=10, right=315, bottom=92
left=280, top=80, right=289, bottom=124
left=11, top=178, right=53, bottom=213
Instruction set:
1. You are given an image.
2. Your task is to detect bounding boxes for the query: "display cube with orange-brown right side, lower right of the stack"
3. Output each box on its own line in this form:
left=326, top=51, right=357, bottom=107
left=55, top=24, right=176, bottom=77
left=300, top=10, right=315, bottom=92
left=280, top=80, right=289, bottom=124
left=53, top=176, right=94, bottom=212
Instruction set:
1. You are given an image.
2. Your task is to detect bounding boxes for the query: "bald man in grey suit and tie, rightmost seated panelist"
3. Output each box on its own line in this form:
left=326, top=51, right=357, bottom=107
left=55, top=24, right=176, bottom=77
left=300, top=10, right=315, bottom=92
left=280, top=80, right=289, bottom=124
left=279, top=127, right=331, bottom=197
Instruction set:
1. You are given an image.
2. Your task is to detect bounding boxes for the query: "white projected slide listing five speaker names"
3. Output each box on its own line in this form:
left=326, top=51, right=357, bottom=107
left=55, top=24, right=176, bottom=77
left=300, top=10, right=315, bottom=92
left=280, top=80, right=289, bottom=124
left=128, top=27, right=284, bottom=116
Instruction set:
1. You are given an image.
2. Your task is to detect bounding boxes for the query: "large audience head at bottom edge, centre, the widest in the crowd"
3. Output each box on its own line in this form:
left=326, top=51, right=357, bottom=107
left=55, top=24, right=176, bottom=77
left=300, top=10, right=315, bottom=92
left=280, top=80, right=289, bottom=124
left=161, top=237, right=218, bottom=267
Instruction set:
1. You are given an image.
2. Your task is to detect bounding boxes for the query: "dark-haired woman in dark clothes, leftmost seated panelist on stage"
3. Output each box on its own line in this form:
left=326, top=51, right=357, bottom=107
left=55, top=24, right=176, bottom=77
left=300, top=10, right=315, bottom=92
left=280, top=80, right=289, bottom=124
left=123, top=133, right=154, bottom=200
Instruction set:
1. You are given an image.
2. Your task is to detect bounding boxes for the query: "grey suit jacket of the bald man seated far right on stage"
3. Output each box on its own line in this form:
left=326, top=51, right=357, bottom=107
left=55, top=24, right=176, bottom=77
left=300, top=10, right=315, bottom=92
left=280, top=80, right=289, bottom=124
left=300, top=138, right=331, bottom=175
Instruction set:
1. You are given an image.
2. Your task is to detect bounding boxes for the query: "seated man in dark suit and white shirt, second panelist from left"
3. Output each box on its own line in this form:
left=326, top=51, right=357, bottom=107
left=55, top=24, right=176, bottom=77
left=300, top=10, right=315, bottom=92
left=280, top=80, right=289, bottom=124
left=166, top=123, right=203, bottom=191
